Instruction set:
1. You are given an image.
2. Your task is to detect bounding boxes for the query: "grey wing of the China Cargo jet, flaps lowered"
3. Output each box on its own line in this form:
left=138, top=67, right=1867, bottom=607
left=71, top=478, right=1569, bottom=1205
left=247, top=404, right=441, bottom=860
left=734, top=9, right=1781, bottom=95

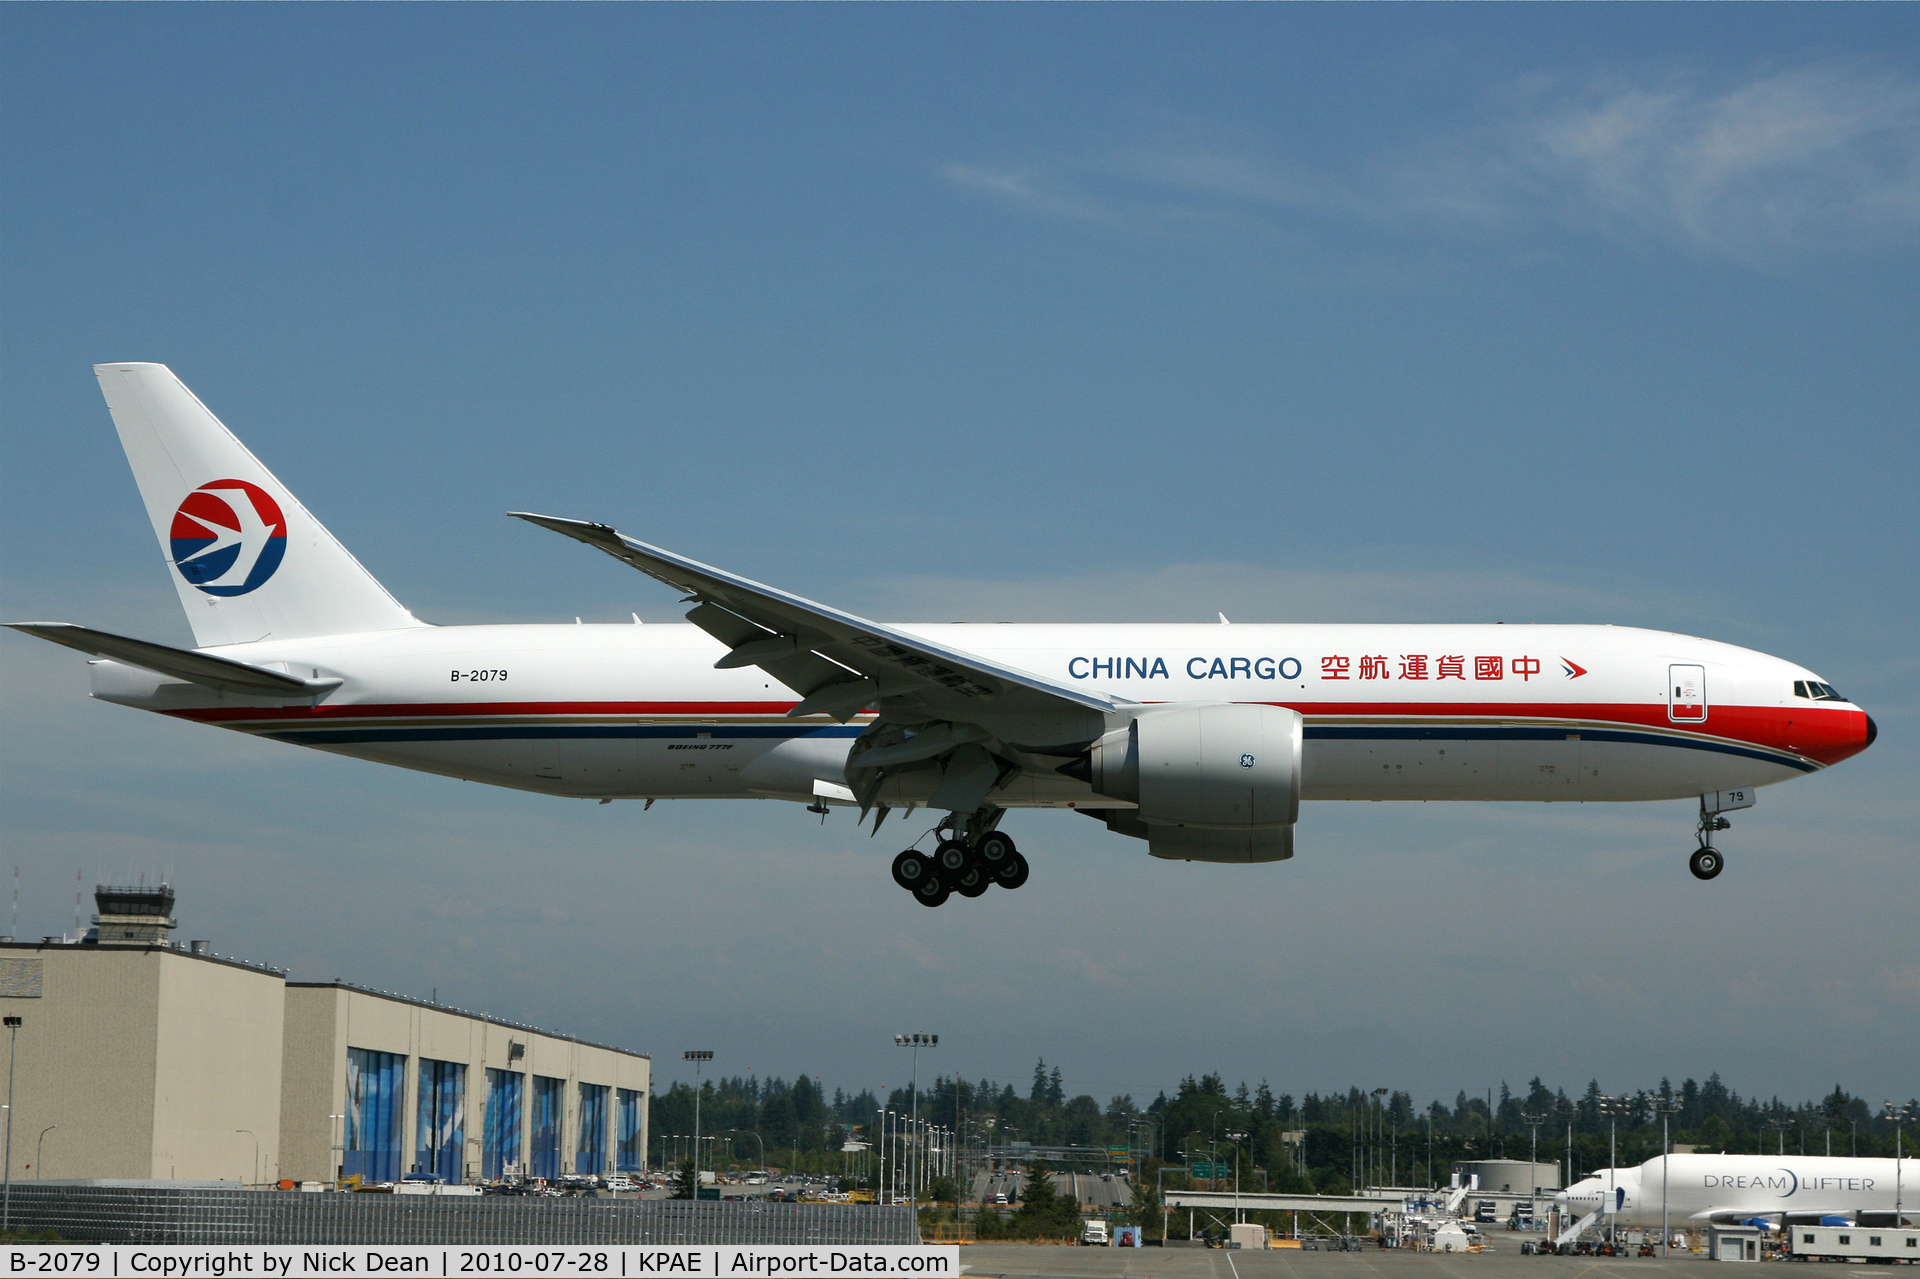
left=511, top=511, right=1117, bottom=724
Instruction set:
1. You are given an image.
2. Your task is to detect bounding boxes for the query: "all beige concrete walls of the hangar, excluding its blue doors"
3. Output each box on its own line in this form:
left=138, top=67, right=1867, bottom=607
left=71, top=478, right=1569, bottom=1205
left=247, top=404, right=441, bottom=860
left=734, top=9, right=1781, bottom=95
left=0, top=945, right=653, bottom=1181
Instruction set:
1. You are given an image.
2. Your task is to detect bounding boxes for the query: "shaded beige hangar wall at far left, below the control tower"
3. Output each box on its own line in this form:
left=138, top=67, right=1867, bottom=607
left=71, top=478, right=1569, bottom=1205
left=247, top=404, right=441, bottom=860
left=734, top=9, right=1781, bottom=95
left=0, top=945, right=161, bottom=1181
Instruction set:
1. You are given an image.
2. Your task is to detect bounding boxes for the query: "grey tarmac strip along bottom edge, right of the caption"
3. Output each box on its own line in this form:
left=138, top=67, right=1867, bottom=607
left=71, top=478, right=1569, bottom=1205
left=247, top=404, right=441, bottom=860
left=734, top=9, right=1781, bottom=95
left=960, top=1243, right=1758, bottom=1279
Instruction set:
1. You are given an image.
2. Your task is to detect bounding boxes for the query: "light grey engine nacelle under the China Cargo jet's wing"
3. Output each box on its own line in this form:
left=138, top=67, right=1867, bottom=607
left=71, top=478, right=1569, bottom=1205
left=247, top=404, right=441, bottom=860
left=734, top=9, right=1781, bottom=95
left=1089, top=703, right=1302, bottom=862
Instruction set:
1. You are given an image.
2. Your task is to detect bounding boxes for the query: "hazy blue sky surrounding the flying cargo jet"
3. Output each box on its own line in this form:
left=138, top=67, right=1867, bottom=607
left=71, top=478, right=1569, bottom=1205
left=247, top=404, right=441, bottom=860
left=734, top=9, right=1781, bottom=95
left=0, top=6, right=1920, bottom=1097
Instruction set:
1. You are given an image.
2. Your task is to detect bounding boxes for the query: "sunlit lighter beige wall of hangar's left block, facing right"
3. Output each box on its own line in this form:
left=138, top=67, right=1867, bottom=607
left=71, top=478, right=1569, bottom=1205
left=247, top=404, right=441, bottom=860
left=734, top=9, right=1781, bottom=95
left=149, top=947, right=286, bottom=1183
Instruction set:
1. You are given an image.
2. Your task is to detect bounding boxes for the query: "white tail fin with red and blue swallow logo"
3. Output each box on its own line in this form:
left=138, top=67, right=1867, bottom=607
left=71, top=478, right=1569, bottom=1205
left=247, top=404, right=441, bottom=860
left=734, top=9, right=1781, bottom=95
left=94, top=365, right=422, bottom=647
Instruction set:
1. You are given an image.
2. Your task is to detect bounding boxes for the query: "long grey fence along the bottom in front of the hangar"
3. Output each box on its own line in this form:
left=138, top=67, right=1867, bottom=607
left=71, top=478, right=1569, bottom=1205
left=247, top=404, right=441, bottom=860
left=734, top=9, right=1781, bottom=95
left=12, top=1183, right=920, bottom=1246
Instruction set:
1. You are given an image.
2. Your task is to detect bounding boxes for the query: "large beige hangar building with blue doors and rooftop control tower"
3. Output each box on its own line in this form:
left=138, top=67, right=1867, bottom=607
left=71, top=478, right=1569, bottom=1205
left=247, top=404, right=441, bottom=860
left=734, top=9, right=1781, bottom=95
left=0, top=887, right=653, bottom=1185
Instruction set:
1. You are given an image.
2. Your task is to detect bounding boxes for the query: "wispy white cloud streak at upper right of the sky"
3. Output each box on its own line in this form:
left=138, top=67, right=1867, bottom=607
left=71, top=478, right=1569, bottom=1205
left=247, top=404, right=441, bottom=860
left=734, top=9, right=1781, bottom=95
left=943, top=63, right=1920, bottom=261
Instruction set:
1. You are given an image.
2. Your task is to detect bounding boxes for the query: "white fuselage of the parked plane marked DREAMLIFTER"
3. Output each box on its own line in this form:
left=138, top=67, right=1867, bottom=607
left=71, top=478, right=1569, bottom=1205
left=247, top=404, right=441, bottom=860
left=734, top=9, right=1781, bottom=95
left=1557, top=1154, right=1920, bottom=1227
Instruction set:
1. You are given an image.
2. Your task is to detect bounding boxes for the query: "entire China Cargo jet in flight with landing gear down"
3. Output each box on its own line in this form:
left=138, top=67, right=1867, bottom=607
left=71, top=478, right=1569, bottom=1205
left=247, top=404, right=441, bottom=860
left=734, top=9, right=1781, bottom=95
left=17, top=365, right=1874, bottom=906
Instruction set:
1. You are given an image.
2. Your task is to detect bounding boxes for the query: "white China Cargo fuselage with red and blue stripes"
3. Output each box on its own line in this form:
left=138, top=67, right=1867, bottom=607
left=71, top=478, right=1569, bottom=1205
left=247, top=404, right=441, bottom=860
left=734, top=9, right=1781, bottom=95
left=94, top=624, right=1870, bottom=808
